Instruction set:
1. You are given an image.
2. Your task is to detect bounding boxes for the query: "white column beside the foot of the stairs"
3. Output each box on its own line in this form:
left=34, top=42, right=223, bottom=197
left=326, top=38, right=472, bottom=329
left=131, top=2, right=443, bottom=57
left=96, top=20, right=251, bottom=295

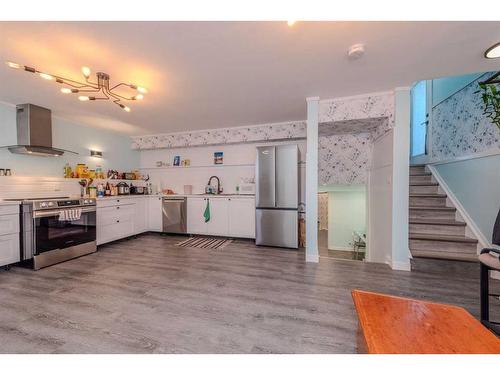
left=392, top=87, right=411, bottom=271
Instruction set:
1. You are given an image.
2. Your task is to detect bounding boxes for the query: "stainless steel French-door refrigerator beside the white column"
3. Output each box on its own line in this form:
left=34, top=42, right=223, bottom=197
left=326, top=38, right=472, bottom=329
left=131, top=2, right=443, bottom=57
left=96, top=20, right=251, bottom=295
left=255, top=145, right=299, bottom=249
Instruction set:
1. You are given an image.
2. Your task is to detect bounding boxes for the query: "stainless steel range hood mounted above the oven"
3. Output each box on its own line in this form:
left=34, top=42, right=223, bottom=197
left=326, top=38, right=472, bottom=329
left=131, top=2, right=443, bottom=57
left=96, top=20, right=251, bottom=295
left=6, top=104, right=76, bottom=156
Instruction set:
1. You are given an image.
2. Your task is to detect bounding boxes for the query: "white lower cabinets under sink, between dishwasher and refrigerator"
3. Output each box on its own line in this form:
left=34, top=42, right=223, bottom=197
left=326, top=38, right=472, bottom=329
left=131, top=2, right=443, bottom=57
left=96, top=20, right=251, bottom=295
left=187, top=197, right=255, bottom=238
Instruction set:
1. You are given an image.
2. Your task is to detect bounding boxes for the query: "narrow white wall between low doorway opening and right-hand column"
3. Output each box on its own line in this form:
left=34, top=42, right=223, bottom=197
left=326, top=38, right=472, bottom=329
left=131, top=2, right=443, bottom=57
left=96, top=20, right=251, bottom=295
left=367, top=130, right=394, bottom=265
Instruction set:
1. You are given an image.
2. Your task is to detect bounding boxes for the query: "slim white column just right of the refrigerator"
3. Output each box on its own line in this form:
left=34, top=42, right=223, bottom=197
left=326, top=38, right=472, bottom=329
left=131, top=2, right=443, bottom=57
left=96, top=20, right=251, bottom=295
left=306, top=97, right=319, bottom=263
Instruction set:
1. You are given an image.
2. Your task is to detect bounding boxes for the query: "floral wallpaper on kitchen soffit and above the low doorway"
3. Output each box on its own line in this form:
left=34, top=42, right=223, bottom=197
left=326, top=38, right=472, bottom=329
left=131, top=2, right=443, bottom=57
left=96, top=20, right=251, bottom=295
left=132, top=92, right=394, bottom=184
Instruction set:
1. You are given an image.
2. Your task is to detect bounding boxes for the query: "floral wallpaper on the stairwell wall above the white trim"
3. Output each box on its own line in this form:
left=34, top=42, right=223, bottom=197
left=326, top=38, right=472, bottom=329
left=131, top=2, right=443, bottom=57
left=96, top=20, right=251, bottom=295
left=431, top=73, right=500, bottom=161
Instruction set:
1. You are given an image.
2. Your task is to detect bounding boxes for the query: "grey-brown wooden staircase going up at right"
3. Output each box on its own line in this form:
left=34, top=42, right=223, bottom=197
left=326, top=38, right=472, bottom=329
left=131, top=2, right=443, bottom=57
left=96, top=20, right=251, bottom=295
left=409, top=166, right=478, bottom=266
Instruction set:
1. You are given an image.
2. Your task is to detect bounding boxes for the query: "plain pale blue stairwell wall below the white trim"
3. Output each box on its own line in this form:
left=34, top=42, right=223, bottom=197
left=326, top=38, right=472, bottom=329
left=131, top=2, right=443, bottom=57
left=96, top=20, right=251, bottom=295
left=435, top=155, right=500, bottom=241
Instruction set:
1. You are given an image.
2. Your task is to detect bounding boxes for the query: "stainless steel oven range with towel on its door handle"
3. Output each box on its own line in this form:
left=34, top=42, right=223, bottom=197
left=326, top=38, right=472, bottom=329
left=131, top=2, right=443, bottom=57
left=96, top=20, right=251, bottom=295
left=21, top=199, right=97, bottom=269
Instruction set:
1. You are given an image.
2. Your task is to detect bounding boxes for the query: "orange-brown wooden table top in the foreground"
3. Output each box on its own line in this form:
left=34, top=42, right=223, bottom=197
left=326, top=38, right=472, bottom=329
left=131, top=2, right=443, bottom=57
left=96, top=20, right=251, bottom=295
left=352, top=290, right=500, bottom=354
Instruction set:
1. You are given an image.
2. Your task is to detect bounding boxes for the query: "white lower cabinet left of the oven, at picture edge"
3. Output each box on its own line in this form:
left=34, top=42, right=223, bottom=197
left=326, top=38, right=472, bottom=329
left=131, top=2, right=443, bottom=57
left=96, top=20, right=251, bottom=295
left=0, top=205, right=20, bottom=266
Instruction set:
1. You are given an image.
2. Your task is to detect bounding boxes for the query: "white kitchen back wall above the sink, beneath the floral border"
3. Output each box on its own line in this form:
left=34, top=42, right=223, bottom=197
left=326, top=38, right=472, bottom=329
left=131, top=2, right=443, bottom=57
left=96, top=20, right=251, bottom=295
left=139, top=140, right=306, bottom=202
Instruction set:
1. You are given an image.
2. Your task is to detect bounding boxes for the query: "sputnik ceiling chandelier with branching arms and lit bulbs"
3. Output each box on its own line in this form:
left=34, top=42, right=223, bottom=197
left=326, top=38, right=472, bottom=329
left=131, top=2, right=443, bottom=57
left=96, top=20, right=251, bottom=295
left=6, top=61, right=148, bottom=112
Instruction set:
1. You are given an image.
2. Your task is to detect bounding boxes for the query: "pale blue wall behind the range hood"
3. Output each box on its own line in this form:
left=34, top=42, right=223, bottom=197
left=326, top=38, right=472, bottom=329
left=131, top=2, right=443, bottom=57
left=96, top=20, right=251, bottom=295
left=0, top=103, right=139, bottom=177
